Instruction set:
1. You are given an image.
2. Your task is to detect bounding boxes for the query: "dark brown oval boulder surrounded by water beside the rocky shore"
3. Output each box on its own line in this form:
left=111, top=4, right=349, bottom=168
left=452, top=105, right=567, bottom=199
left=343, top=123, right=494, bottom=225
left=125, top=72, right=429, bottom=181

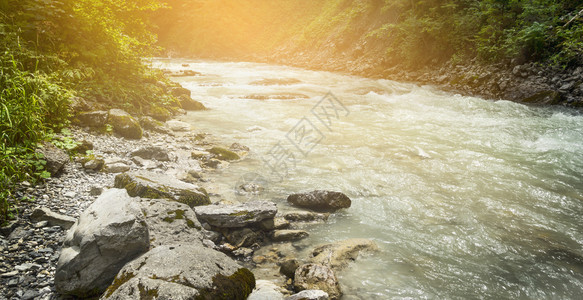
left=287, top=190, right=352, bottom=211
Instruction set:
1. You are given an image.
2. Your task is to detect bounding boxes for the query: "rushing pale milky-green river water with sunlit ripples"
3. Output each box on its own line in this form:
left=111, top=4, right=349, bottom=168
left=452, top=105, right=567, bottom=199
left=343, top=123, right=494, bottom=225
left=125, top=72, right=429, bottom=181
left=154, top=59, right=583, bottom=299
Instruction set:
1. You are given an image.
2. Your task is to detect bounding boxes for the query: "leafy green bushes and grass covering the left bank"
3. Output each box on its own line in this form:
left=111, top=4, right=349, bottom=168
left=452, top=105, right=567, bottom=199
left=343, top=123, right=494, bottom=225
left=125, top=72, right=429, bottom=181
left=0, top=0, right=171, bottom=223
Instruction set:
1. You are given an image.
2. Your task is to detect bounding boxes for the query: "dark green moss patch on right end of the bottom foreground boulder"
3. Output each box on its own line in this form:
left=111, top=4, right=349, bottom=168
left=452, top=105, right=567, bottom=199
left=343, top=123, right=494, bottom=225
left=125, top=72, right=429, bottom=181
left=196, top=268, right=255, bottom=300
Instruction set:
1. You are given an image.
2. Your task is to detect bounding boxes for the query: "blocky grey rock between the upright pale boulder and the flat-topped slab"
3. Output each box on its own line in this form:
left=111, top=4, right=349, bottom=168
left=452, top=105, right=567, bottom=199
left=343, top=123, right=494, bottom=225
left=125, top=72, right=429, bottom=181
left=136, top=199, right=203, bottom=248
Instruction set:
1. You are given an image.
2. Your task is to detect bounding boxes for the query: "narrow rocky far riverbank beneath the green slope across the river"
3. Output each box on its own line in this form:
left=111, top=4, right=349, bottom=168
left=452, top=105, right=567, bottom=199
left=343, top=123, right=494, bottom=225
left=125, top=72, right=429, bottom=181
left=264, top=51, right=583, bottom=110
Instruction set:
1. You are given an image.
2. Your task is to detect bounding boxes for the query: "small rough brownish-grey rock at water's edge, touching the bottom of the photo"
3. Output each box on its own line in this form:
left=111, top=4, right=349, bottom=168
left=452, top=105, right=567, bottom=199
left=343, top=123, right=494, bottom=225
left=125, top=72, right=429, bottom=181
left=294, top=264, right=342, bottom=299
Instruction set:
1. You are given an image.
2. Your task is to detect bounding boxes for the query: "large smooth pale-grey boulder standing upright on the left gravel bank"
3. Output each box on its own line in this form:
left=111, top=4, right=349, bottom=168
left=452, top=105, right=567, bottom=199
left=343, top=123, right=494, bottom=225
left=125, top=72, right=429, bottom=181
left=55, top=189, right=150, bottom=297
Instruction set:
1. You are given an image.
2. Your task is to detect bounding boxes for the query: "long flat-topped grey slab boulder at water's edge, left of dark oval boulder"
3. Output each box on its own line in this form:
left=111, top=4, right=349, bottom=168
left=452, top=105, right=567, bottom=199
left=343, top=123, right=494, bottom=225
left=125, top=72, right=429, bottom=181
left=194, top=201, right=277, bottom=228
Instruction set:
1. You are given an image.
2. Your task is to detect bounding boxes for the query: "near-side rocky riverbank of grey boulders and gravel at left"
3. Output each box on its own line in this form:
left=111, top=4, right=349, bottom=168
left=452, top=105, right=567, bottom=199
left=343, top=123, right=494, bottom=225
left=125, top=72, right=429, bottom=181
left=0, top=77, right=377, bottom=299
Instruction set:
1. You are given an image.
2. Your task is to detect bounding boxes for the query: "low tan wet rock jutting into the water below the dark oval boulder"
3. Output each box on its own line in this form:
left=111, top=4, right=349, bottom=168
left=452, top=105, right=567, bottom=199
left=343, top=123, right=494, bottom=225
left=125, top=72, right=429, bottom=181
left=310, top=239, right=378, bottom=271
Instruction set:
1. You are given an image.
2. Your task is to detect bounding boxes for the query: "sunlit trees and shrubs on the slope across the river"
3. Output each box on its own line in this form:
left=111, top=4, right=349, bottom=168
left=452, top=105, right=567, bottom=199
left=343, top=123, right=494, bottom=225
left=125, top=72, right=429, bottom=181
left=155, top=0, right=583, bottom=68
